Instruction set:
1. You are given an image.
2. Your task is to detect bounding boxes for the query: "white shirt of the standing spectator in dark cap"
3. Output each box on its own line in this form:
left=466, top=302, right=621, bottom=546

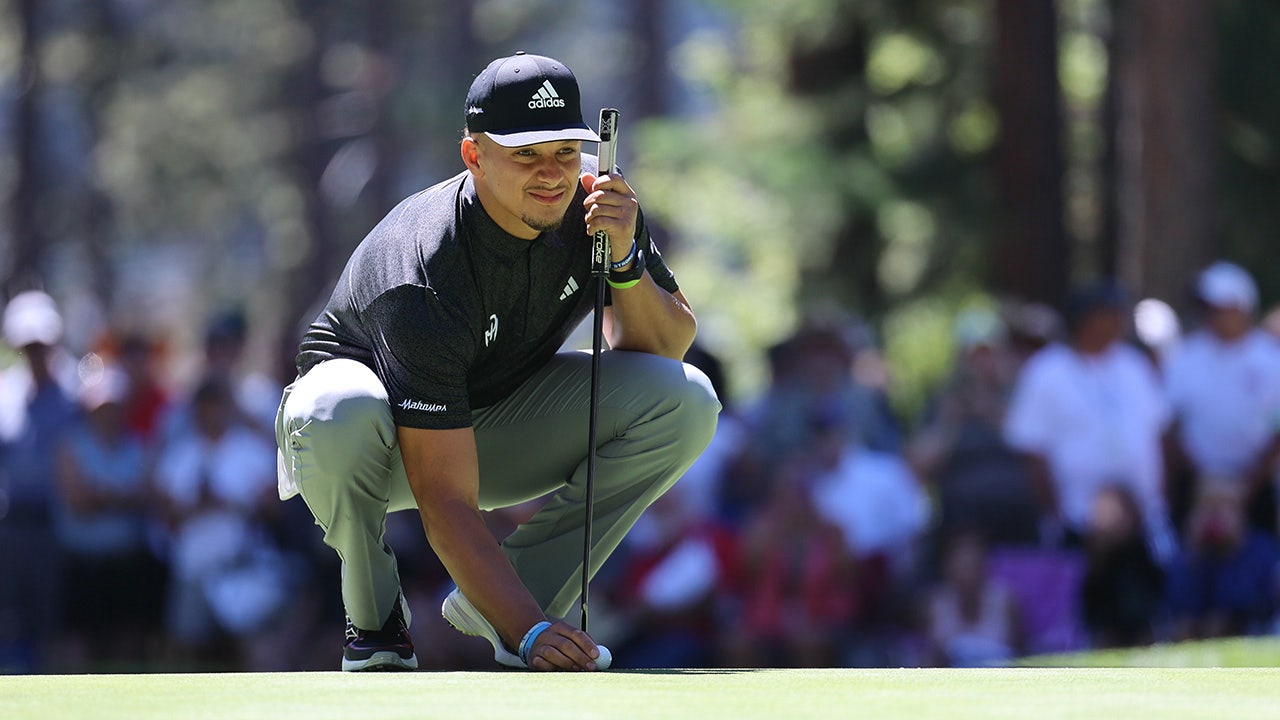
left=1004, top=342, right=1170, bottom=533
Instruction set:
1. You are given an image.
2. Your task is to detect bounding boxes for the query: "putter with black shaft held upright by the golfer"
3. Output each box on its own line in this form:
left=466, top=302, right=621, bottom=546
left=581, top=108, right=618, bottom=633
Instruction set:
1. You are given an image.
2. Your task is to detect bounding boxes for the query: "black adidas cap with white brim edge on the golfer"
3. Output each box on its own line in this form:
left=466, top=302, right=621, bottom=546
left=466, top=53, right=600, bottom=147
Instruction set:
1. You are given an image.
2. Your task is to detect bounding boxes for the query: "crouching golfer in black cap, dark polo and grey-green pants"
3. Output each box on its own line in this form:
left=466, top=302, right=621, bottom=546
left=276, top=53, right=719, bottom=670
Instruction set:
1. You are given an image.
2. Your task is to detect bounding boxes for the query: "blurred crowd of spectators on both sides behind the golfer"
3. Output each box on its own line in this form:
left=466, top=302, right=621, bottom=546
left=0, top=261, right=1280, bottom=673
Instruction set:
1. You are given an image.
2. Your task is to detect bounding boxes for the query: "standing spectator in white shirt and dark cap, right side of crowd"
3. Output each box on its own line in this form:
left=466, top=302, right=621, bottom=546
left=1004, top=283, right=1170, bottom=557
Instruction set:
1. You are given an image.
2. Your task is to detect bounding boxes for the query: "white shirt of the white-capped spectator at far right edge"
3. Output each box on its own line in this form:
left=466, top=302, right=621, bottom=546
left=1165, top=329, right=1280, bottom=479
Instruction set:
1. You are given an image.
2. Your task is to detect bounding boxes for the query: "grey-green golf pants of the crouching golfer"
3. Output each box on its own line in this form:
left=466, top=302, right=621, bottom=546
left=276, top=351, right=721, bottom=628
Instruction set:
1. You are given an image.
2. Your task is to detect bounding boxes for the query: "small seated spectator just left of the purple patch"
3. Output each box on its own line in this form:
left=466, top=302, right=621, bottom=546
left=925, top=529, right=1023, bottom=667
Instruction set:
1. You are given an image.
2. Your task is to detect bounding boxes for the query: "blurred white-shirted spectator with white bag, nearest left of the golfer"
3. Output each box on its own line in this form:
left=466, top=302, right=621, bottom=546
left=156, top=377, right=289, bottom=665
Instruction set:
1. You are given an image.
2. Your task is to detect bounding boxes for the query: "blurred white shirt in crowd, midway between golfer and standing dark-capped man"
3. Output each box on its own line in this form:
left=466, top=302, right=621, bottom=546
left=813, top=446, right=929, bottom=565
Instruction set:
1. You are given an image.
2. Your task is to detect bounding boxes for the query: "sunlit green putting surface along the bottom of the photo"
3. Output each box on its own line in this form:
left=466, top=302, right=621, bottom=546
left=0, top=641, right=1280, bottom=720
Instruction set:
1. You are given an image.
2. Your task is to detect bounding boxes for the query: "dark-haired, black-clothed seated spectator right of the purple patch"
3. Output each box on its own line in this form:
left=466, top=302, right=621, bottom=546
left=1080, top=486, right=1165, bottom=647
